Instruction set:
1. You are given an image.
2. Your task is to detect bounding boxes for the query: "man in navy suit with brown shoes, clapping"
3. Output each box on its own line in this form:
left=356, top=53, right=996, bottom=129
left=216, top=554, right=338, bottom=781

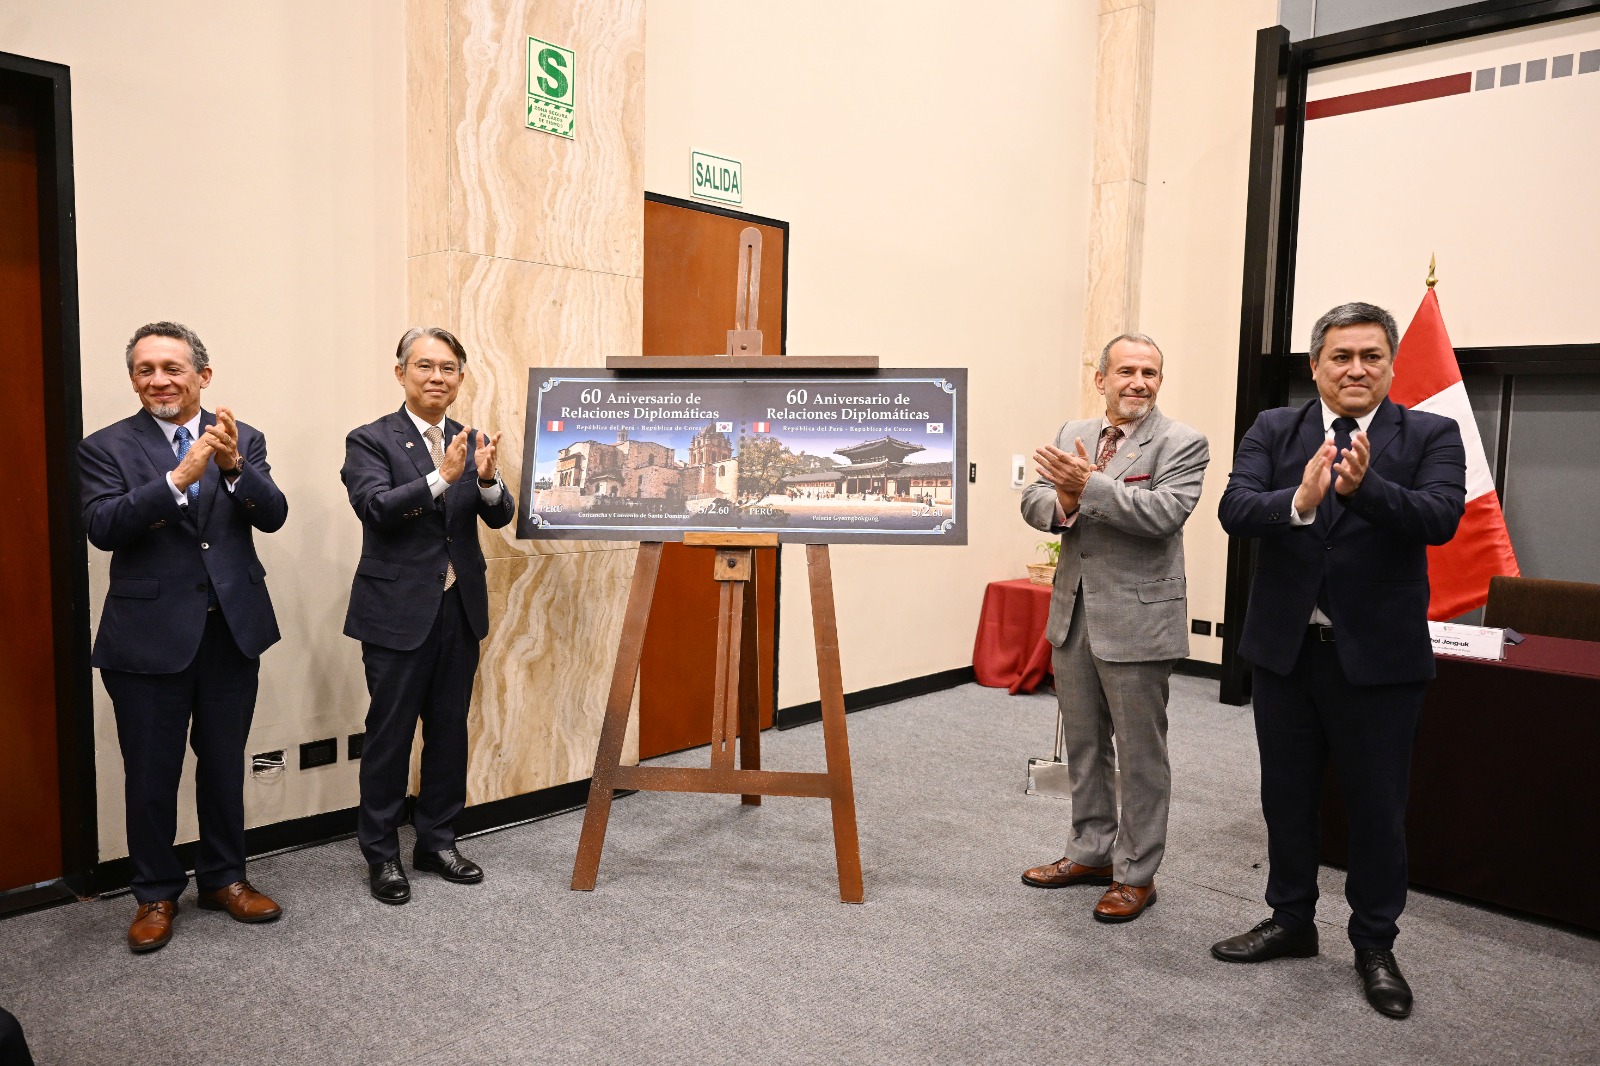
left=78, top=322, right=288, bottom=952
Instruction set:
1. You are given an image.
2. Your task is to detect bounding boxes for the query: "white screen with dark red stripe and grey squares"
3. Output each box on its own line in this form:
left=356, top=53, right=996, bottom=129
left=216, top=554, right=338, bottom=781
left=1291, top=14, right=1600, bottom=352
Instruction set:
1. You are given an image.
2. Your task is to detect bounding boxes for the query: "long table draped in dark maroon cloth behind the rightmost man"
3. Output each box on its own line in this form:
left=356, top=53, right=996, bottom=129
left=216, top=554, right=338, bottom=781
left=1322, top=635, right=1600, bottom=930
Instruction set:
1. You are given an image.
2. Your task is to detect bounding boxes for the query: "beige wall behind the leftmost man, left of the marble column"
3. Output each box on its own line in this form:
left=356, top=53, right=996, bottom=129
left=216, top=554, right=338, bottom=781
left=0, top=0, right=405, bottom=858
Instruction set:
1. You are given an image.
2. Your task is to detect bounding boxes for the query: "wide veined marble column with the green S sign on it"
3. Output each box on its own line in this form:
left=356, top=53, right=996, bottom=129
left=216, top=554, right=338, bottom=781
left=405, top=0, right=645, bottom=804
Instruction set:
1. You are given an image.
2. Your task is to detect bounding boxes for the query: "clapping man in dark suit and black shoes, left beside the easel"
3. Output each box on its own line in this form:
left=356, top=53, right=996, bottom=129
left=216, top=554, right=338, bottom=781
left=341, top=327, right=515, bottom=904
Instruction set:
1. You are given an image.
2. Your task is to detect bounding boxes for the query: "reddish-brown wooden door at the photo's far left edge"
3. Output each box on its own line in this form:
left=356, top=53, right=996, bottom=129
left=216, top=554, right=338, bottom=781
left=0, top=82, right=62, bottom=892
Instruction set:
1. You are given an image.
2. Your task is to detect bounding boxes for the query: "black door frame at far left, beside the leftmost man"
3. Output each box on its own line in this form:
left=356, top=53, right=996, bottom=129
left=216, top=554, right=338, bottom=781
left=0, top=51, right=99, bottom=914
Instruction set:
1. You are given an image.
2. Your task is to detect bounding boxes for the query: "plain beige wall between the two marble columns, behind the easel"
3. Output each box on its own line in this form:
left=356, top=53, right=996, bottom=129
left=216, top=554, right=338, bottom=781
left=645, top=0, right=1098, bottom=706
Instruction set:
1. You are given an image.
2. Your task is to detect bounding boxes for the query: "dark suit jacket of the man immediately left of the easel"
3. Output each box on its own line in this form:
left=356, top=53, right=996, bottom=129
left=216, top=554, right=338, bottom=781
left=339, top=407, right=517, bottom=651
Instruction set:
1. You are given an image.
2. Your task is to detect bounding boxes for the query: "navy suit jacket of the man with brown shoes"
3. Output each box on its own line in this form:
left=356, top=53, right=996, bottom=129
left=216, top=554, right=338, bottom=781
left=78, top=410, right=290, bottom=674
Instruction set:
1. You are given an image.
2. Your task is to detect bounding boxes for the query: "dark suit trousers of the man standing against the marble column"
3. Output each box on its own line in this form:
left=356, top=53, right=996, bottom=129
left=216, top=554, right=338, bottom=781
left=355, top=587, right=478, bottom=863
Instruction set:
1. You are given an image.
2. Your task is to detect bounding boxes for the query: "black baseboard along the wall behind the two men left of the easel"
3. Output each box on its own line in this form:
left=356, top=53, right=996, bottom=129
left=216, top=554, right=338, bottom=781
left=80, top=778, right=608, bottom=895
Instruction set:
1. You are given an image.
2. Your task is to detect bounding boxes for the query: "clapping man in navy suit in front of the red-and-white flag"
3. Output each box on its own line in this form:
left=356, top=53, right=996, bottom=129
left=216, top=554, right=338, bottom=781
left=1211, top=303, right=1467, bottom=1018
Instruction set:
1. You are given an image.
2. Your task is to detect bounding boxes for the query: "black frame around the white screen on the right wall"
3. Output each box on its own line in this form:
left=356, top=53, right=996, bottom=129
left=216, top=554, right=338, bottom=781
left=1221, top=0, right=1600, bottom=704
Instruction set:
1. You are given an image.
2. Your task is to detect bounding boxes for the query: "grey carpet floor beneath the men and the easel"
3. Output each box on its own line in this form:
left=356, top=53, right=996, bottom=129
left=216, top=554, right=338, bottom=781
left=0, top=677, right=1600, bottom=1066
